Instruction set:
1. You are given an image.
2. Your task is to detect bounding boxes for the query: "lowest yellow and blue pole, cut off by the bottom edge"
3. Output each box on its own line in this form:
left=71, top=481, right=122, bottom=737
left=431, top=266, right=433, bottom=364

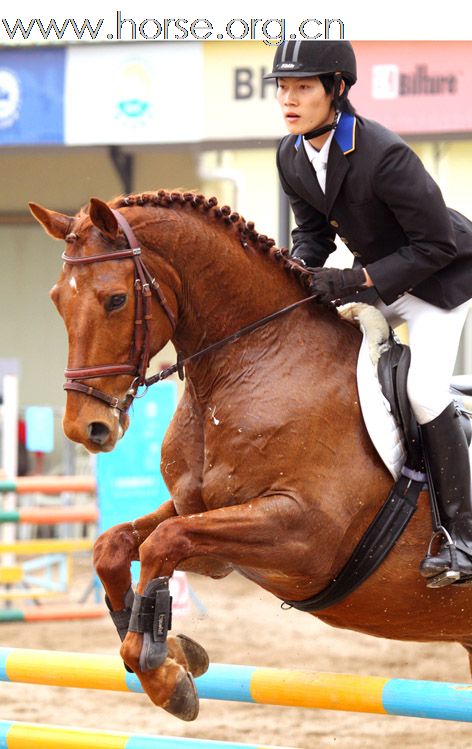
left=0, top=720, right=294, bottom=749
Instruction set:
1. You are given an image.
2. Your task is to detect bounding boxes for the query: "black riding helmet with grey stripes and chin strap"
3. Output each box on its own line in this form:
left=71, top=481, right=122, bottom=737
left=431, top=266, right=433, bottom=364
left=264, top=39, right=357, bottom=140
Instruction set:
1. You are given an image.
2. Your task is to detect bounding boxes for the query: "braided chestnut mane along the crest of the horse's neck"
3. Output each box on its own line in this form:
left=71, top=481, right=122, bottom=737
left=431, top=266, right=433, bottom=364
left=111, top=190, right=309, bottom=290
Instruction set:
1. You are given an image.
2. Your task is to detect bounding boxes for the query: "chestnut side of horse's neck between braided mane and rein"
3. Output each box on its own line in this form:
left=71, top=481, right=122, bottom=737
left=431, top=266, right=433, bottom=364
left=146, top=213, right=304, bottom=354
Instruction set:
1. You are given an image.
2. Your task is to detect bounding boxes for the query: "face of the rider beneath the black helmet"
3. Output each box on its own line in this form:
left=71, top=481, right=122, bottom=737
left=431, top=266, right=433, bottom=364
left=277, top=76, right=335, bottom=135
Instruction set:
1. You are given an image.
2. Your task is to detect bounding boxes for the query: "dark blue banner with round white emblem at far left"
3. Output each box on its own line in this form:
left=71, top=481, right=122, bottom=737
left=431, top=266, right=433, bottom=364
left=0, top=48, right=65, bottom=145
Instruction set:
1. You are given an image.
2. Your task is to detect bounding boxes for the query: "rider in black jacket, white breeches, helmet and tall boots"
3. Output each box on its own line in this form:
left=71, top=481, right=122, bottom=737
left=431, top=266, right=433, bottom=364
left=267, top=40, right=472, bottom=584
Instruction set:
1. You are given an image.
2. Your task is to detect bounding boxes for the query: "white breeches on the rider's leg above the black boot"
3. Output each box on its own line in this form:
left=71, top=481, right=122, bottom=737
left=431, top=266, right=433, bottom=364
left=375, top=294, right=470, bottom=424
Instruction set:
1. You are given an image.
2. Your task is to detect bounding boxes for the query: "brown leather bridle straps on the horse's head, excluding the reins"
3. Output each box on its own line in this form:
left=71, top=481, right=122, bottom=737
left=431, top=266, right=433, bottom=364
left=62, top=208, right=176, bottom=413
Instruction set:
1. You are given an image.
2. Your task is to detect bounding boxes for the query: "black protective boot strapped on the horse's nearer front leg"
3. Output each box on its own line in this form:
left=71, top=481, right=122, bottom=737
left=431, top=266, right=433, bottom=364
left=128, top=577, right=172, bottom=671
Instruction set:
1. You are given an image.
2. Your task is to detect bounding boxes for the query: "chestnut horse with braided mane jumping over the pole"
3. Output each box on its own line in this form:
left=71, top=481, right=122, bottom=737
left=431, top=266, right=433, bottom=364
left=31, top=191, right=472, bottom=720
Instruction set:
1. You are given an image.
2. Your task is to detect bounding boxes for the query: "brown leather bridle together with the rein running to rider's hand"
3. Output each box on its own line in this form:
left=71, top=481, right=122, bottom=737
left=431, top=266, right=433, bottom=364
left=62, top=209, right=316, bottom=413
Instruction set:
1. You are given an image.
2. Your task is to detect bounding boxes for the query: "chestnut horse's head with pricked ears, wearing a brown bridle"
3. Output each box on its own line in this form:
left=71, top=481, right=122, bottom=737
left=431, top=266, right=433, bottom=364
left=30, top=198, right=177, bottom=452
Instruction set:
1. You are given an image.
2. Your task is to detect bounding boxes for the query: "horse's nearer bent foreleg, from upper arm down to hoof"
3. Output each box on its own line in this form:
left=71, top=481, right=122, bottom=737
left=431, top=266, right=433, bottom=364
left=121, top=496, right=309, bottom=720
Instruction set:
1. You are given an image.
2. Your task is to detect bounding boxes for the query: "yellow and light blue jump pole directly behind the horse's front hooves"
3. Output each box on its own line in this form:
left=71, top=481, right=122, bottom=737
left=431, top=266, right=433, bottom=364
left=0, top=648, right=472, bottom=723
